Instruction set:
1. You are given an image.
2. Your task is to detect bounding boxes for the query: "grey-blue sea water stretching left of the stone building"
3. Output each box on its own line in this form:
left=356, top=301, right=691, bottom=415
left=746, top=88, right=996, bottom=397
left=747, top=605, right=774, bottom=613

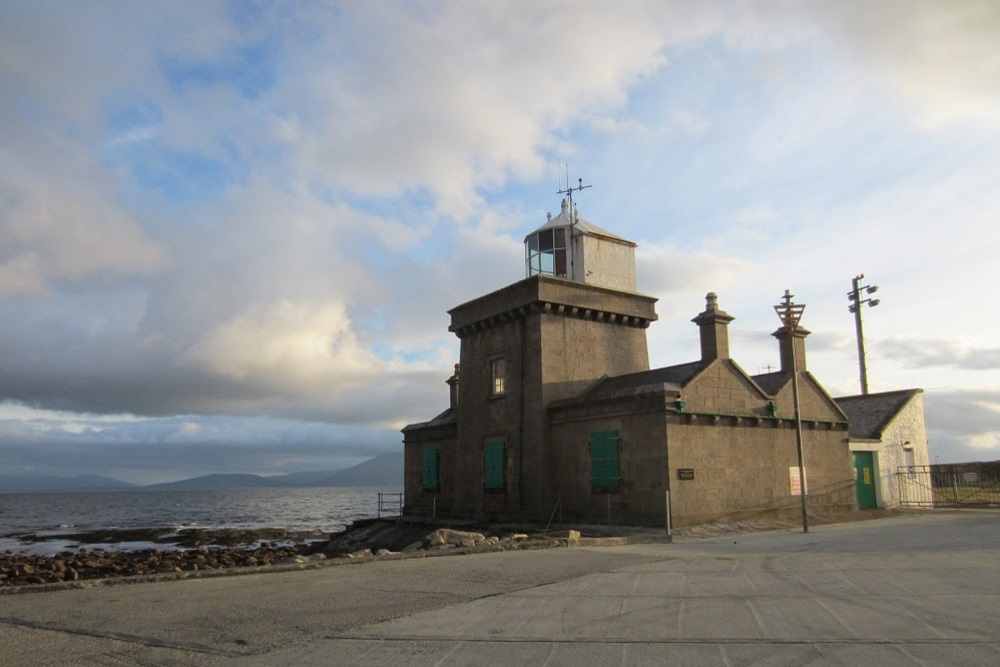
left=0, top=486, right=403, bottom=553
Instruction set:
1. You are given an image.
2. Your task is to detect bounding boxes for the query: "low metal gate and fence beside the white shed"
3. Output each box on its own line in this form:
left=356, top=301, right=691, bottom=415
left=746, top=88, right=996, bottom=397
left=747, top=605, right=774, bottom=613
left=896, top=465, right=1000, bottom=507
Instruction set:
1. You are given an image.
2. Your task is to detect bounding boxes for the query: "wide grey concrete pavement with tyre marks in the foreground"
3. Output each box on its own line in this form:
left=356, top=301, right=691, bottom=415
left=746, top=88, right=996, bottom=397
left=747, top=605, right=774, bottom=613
left=0, top=511, right=1000, bottom=667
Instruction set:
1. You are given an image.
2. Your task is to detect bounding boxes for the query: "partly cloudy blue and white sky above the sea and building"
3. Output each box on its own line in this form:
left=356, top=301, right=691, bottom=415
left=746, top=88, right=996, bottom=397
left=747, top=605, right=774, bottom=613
left=0, top=0, right=1000, bottom=483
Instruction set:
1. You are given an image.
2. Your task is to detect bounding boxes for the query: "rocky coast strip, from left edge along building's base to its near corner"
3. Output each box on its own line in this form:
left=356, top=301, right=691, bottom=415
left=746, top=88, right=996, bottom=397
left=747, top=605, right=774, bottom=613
left=0, top=519, right=669, bottom=595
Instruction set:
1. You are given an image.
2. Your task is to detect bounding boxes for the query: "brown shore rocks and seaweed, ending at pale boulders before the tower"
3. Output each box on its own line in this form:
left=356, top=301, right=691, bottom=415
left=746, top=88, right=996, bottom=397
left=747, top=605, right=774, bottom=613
left=0, top=520, right=579, bottom=590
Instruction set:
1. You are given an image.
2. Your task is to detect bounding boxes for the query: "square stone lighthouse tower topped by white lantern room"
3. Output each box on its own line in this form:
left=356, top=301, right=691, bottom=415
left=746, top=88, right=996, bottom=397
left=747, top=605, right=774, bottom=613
left=436, top=201, right=656, bottom=519
